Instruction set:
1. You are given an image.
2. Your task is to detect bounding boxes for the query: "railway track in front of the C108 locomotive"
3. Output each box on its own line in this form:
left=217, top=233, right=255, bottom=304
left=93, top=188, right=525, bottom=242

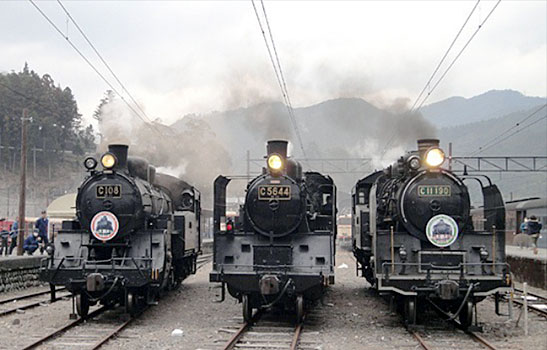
left=21, top=306, right=144, bottom=350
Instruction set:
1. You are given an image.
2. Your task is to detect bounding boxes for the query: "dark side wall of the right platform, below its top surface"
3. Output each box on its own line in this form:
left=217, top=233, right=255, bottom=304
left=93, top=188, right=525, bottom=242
left=507, top=256, right=547, bottom=289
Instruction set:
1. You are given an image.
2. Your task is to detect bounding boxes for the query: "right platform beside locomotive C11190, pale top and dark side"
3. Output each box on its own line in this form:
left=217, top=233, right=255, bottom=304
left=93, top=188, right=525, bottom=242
left=505, top=245, right=547, bottom=290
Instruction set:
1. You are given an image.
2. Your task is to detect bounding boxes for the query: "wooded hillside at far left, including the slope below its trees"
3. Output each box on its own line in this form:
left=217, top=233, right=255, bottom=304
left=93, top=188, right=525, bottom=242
left=0, top=64, right=95, bottom=218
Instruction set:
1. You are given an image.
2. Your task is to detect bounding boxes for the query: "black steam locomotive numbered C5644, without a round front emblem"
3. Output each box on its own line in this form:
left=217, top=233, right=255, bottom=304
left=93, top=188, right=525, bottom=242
left=210, top=140, right=336, bottom=321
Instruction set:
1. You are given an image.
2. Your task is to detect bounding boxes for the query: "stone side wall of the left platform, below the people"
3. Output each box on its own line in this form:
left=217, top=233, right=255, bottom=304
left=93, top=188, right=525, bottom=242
left=0, top=256, right=44, bottom=293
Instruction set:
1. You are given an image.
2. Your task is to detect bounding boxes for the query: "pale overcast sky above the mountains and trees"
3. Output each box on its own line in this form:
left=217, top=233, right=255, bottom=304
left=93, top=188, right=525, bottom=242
left=0, top=1, right=547, bottom=126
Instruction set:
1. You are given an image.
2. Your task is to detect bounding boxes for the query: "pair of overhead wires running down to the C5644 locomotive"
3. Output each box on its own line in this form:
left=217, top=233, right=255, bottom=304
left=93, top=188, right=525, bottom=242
left=251, top=0, right=307, bottom=159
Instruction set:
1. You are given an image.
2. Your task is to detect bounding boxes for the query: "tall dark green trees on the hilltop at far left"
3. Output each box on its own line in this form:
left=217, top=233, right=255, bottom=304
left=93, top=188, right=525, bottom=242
left=0, top=64, right=95, bottom=171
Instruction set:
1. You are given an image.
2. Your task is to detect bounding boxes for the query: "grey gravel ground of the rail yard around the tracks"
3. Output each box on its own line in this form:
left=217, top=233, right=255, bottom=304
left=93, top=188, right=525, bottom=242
left=0, top=250, right=547, bottom=350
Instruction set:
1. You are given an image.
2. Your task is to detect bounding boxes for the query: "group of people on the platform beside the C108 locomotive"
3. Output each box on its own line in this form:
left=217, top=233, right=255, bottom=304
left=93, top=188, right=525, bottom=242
left=0, top=210, right=49, bottom=256
